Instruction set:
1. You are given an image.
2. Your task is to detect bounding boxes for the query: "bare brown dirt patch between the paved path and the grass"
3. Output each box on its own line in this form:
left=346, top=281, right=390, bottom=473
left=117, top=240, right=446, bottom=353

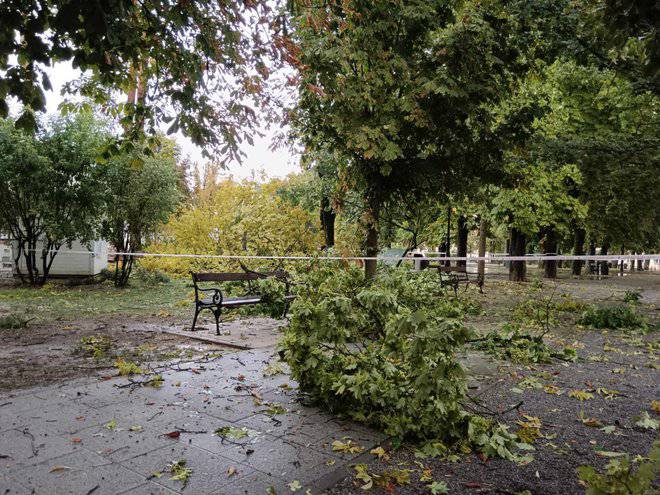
left=0, top=316, right=233, bottom=390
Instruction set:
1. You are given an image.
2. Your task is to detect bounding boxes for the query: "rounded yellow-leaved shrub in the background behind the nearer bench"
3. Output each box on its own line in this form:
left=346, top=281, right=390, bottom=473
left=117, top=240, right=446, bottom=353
left=140, top=179, right=321, bottom=277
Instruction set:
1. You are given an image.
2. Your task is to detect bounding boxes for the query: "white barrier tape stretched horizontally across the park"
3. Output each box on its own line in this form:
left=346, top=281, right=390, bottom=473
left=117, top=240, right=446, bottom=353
left=20, top=249, right=660, bottom=262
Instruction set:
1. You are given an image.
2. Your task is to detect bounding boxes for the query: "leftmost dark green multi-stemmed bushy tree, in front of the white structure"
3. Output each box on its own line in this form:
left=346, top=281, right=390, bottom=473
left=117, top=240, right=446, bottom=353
left=0, top=114, right=108, bottom=284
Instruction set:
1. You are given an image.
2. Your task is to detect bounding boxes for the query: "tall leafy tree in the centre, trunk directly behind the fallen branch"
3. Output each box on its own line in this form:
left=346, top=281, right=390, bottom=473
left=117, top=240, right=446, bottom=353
left=289, top=0, right=565, bottom=276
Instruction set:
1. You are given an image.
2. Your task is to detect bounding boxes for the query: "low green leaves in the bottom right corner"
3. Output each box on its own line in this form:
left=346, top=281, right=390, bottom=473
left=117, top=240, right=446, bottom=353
left=578, top=441, right=660, bottom=495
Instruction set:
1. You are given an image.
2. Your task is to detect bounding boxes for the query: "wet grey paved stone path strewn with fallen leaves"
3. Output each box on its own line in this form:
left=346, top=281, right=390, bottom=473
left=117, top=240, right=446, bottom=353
left=0, top=348, right=385, bottom=495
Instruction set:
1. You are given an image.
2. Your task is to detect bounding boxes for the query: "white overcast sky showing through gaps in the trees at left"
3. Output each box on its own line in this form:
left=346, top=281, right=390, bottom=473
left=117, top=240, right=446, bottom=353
left=30, top=62, right=299, bottom=179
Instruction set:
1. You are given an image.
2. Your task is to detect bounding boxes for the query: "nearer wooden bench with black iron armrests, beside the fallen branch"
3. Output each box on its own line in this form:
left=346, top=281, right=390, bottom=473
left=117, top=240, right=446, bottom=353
left=190, top=270, right=295, bottom=335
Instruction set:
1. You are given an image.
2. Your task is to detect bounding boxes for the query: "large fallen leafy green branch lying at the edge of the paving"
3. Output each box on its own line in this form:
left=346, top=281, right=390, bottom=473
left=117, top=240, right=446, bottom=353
left=281, top=268, right=470, bottom=441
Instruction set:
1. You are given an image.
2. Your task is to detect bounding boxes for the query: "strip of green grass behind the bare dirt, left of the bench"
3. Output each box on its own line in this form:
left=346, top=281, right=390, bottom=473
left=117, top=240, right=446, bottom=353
left=0, top=279, right=194, bottom=321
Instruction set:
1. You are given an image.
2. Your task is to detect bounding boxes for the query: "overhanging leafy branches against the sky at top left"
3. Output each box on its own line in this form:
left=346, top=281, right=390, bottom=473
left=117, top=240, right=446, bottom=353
left=0, top=0, right=279, bottom=158
